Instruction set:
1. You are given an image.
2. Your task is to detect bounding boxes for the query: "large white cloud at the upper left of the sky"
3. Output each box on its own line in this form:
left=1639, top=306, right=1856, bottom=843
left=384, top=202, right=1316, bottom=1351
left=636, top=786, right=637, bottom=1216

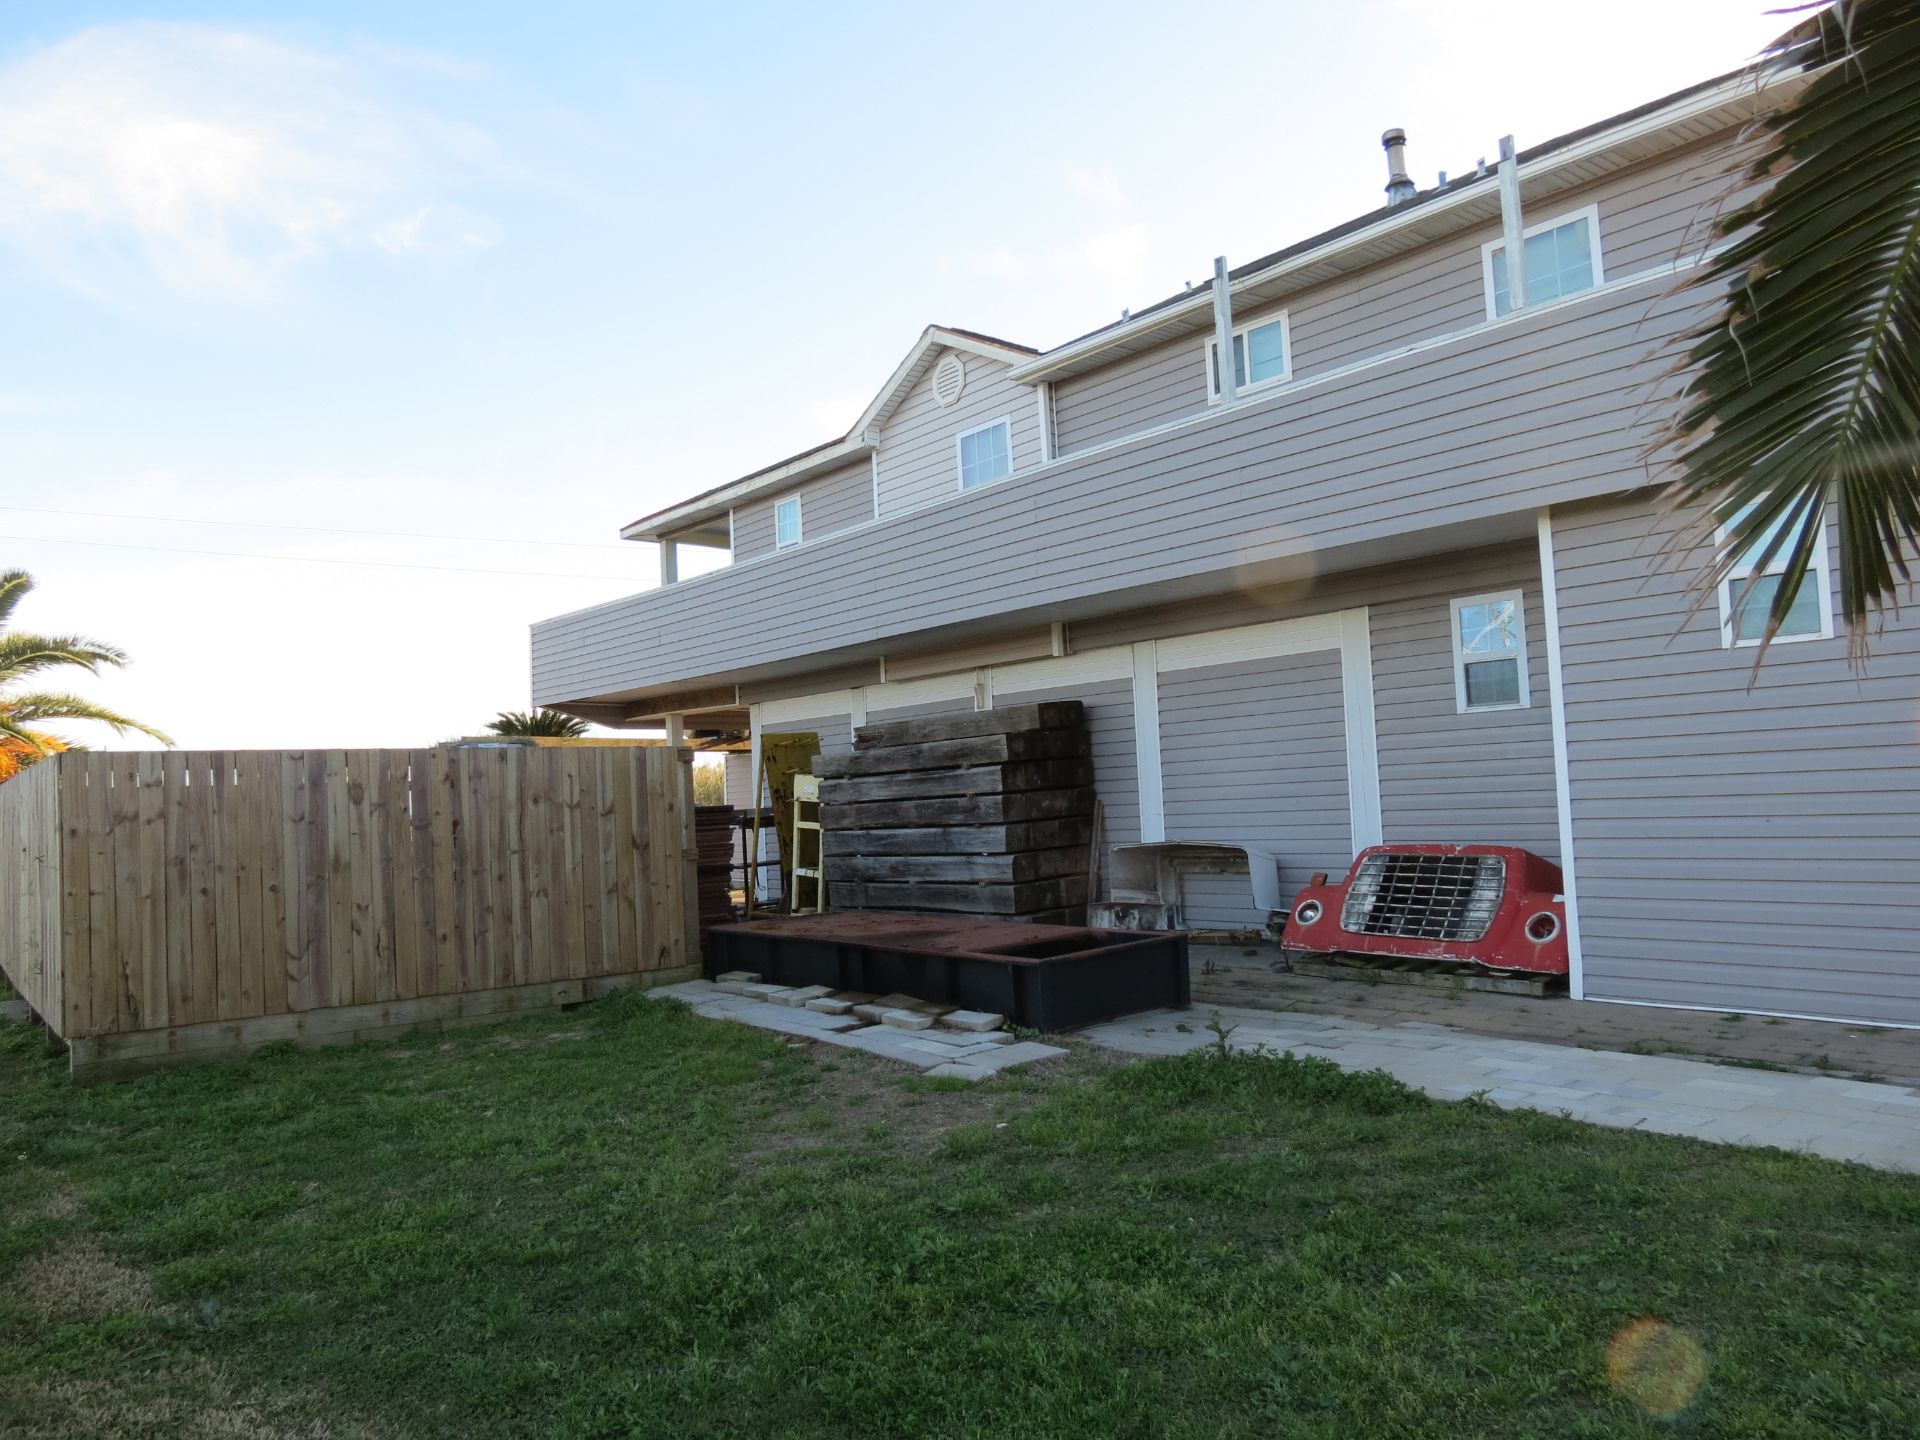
left=0, top=23, right=497, bottom=300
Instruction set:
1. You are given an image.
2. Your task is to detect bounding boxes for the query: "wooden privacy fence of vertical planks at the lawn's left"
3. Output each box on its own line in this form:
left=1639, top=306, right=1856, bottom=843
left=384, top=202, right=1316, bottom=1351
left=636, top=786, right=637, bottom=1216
left=0, top=745, right=699, bottom=1064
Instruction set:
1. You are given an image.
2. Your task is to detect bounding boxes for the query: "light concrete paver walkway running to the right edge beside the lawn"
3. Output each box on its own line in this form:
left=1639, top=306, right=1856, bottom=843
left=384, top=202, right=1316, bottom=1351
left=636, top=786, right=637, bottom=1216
left=1081, top=1006, right=1920, bottom=1171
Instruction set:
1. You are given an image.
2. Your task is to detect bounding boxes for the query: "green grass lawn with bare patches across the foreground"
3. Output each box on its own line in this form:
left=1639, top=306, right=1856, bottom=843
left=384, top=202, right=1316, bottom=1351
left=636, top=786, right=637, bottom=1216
left=0, top=996, right=1920, bottom=1440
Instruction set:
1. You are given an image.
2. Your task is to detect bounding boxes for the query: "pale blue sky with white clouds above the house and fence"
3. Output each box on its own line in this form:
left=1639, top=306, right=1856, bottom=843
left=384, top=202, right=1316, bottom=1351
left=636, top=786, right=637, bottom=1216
left=0, top=0, right=1782, bottom=747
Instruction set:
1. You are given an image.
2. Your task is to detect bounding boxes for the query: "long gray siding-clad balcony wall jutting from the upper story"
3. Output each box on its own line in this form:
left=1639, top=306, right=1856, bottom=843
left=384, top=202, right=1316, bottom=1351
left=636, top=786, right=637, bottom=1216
left=534, top=259, right=1705, bottom=703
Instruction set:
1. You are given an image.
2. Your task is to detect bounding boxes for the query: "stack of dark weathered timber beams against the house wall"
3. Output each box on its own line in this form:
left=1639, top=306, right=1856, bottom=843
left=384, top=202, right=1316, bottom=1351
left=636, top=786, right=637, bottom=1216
left=814, top=701, right=1094, bottom=925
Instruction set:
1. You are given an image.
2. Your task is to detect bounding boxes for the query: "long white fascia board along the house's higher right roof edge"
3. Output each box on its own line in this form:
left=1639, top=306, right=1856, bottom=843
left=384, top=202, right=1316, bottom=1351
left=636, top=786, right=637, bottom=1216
left=1008, top=75, right=1799, bottom=384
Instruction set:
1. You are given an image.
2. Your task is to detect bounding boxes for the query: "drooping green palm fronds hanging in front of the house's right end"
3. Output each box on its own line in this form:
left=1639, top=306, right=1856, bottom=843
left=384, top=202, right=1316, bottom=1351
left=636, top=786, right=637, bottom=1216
left=1661, top=0, right=1920, bottom=660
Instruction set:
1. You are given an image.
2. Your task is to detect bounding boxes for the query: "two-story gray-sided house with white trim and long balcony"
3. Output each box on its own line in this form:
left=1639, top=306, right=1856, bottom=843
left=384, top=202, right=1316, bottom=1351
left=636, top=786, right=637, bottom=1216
left=534, top=67, right=1920, bottom=1025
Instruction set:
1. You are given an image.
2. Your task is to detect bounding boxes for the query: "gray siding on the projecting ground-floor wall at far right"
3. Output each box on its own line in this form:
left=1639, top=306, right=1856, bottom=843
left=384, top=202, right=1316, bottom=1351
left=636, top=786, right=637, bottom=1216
left=1553, top=497, right=1920, bottom=1023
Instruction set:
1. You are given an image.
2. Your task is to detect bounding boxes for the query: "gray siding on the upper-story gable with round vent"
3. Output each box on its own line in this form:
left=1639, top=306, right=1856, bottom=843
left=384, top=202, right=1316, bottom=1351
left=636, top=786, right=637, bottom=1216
left=877, top=349, right=1041, bottom=515
